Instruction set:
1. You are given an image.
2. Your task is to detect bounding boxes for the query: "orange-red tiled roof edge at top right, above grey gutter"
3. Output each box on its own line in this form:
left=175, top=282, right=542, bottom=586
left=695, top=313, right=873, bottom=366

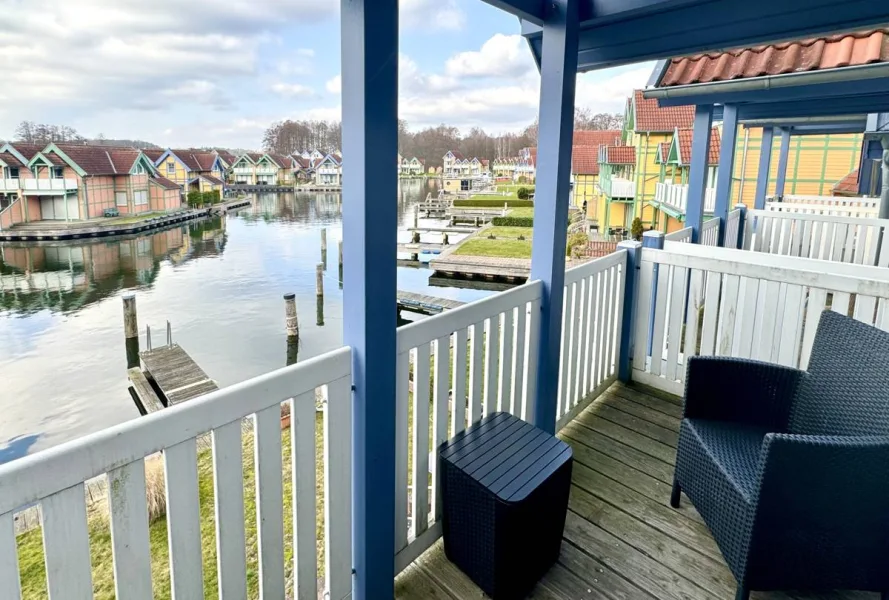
left=658, top=29, right=889, bottom=87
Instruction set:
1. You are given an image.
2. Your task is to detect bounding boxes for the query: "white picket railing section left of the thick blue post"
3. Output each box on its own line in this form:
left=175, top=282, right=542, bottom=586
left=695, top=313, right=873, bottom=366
left=0, top=348, right=352, bottom=600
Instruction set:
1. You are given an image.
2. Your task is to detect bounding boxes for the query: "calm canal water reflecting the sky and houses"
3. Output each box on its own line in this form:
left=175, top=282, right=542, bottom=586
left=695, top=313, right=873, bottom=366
left=0, top=180, right=491, bottom=463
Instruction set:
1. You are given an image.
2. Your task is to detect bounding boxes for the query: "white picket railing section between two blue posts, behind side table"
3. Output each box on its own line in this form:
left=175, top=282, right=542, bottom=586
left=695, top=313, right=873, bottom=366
left=395, top=281, right=543, bottom=573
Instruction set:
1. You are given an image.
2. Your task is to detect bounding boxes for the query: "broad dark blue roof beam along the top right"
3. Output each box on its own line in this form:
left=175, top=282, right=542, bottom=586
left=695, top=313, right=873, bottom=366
left=524, top=0, right=889, bottom=71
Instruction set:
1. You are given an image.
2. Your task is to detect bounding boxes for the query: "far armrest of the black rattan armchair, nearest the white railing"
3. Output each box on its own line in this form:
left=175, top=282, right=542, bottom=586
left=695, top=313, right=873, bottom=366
left=684, top=356, right=807, bottom=432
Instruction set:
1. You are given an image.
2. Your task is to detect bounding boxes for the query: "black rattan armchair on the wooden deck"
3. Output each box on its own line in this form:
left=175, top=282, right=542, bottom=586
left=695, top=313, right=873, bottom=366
left=670, top=312, right=889, bottom=600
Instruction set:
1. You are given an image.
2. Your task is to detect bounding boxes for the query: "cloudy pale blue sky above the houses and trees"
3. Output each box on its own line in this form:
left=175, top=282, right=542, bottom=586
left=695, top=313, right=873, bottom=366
left=0, top=0, right=652, bottom=148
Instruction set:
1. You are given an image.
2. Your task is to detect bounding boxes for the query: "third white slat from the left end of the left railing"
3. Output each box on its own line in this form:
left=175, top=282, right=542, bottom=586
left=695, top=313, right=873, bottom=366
left=106, top=460, right=152, bottom=600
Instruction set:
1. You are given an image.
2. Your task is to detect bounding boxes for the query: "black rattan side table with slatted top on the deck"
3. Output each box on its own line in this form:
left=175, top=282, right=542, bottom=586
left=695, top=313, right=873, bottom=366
left=438, top=413, right=572, bottom=600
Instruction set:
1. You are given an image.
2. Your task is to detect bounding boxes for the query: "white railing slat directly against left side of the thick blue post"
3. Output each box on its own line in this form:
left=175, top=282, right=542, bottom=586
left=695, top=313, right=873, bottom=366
left=324, top=378, right=352, bottom=600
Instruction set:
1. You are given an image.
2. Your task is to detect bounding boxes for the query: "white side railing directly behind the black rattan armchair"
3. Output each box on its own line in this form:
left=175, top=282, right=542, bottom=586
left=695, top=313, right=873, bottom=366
left=633, top=243, right=889, bottom=394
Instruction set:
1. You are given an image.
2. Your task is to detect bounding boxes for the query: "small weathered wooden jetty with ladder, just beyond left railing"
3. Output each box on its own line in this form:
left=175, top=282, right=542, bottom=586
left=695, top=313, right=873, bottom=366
left=139, top=344, right=219, bottom=406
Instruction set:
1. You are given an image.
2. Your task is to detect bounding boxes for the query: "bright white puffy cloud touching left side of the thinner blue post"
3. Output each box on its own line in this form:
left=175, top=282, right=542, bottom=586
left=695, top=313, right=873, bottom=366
left=445, top=33, right=535, bottom=78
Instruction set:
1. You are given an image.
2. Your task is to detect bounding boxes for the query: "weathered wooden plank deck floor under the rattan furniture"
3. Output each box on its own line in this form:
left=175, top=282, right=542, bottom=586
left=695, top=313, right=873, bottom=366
left=396, top=384, right=878, bottom=600
